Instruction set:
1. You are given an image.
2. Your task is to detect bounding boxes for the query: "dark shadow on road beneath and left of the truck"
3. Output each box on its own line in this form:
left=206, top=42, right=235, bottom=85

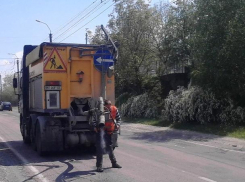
left=0, top=141, right=96, bottom=182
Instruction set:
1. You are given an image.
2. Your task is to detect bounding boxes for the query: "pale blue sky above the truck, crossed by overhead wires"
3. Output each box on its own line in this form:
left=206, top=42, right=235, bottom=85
left=0, top=0, right=164, bottom=77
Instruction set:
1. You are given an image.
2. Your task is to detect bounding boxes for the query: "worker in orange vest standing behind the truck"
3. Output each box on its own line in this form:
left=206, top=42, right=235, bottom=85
left=95, top=100, right=122, bottom=172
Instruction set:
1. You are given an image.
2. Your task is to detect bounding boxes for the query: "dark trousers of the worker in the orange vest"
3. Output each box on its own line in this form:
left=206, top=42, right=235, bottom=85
left=96, top=131, right=117, bottom=167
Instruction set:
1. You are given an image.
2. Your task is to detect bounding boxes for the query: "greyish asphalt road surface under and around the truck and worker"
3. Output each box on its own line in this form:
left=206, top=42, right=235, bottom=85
left=0, top=109, right=245, bottom=182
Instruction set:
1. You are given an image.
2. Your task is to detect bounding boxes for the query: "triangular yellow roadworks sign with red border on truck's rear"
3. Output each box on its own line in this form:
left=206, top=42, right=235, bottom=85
left=43, top=48, right=66, bottom=72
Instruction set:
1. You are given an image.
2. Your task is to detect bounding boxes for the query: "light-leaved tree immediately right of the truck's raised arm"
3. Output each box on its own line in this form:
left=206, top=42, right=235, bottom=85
left=108, top=0, right=159, bottom=95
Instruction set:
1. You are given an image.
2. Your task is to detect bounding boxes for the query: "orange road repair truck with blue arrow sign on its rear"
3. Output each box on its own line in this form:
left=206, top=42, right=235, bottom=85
left=13, top=26, right=117, bottom=155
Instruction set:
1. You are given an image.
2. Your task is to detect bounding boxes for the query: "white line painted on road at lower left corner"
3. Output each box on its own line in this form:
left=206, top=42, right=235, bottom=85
left=0, top=136, right=49, bottom=182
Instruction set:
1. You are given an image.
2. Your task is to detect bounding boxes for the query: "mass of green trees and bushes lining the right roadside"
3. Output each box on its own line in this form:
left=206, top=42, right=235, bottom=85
left=89, top=0, right=245, bottom=124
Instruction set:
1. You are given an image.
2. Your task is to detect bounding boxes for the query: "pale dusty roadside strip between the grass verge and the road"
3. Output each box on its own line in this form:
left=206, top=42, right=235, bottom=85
left=121, top=122, right=245, bottom=154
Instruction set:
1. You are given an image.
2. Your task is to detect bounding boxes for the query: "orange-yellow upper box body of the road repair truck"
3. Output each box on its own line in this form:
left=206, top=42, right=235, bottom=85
left=26, top=43, right=115, bottom=109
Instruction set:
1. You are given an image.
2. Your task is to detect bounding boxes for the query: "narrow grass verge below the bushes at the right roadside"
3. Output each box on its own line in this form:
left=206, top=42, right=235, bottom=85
left=123, top=118, right=245, bottom=139
